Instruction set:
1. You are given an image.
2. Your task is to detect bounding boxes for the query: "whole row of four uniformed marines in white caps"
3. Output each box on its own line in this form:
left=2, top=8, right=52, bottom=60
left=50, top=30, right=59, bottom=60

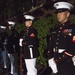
left=0, top=2, right=75, bottom=75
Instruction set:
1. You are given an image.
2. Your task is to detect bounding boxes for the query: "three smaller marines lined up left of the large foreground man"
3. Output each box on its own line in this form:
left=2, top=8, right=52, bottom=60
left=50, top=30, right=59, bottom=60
left=0, top=15, right=39, bottom=75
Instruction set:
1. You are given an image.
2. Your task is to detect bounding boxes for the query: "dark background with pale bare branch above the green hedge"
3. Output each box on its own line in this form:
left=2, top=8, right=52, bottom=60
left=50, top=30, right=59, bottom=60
left=0, top=0, right=75, bottom=25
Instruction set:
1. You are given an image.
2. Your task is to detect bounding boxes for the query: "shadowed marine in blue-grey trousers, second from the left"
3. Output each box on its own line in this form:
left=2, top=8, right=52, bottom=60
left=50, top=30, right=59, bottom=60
left=7, top=21, right=20, bottom=74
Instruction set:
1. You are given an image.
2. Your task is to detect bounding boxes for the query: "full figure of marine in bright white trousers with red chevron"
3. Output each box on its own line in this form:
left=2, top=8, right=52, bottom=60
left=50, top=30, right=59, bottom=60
left=21, top=15, right=39, bottom=75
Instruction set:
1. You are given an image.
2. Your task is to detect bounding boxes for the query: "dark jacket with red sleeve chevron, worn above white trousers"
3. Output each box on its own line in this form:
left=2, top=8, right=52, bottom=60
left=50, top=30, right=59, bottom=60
left=21, top=26, right=38, bottom=59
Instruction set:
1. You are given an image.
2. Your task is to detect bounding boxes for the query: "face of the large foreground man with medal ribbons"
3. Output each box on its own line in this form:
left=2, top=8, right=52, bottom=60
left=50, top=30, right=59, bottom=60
left=57, top=11, right=70, bottom=23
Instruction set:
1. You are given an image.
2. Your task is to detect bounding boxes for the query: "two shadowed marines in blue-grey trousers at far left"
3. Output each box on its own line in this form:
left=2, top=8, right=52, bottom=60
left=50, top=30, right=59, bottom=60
left=0, top=21, right=20, bottom=75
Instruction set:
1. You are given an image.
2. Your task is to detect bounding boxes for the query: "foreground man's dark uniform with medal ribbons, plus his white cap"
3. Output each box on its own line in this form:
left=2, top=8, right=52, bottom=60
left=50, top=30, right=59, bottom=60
left=48, top=2, right=75, bottom=75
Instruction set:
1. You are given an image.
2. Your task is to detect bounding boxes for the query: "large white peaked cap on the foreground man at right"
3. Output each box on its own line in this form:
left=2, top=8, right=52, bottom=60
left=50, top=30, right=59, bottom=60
left=54, top=2, right=73, bottom=10
